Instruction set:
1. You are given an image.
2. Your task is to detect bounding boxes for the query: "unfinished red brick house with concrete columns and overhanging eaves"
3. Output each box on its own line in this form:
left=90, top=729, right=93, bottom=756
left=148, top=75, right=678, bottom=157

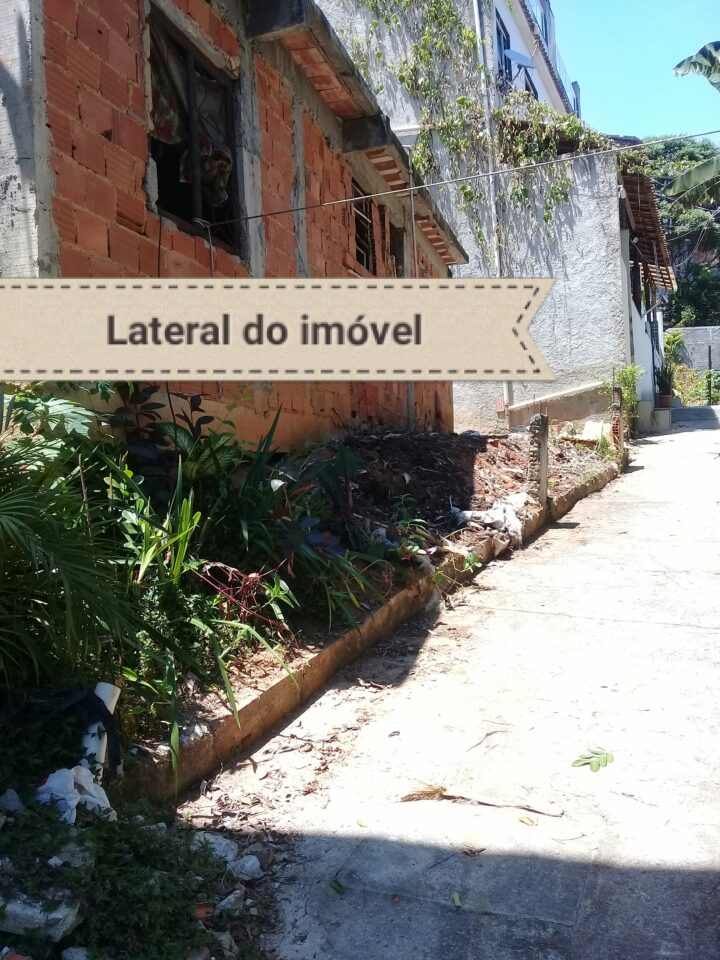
left=0, top=0, right=466, bottom=444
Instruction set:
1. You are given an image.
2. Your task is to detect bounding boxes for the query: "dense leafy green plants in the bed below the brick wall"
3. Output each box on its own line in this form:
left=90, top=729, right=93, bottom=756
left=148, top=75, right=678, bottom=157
left=0, top=385, right=392, bottom=754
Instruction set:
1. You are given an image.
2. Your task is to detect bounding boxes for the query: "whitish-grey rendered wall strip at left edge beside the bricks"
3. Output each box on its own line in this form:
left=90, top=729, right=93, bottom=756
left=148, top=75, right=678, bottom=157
left=0, top=0, right=57, bottom=277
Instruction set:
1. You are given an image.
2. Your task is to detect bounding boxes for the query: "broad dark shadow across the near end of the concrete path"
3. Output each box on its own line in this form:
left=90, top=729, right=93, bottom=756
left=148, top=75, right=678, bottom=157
left=201, top=816, right=720, bottom=960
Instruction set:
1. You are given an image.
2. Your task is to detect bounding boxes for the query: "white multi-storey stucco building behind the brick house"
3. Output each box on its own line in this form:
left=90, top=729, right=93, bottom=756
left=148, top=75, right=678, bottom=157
left=320, top=0, right=674, bottom=431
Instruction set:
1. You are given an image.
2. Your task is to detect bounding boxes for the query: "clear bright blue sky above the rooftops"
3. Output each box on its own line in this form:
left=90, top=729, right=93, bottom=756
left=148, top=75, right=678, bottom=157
left=552, top=0, right=720, bottom=141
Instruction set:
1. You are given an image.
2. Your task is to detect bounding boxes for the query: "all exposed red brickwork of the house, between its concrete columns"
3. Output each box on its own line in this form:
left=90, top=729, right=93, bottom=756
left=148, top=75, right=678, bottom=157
left=44, top=0, right=452, bottom=445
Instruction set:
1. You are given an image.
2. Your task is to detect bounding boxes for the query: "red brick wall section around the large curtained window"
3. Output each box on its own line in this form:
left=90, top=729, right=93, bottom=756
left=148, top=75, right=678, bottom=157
left=45, top=0, right=247, bottom=277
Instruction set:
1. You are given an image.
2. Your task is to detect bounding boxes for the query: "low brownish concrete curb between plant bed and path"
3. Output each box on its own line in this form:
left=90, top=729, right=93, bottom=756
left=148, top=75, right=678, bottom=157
left=115, top=464, right=620, bottom=801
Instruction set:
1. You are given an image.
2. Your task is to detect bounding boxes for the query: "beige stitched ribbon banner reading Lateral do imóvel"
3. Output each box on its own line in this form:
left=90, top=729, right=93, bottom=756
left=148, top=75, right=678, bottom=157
left=0, top=279, right=554, bottom=381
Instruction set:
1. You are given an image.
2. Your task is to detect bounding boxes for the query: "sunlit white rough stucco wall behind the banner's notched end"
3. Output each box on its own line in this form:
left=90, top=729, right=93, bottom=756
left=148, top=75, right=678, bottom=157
left=455, top=157, right=627, bottom=430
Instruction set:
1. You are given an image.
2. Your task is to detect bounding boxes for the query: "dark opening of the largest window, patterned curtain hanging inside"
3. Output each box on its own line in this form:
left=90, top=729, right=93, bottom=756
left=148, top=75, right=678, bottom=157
left=150, top=15, right=241, bottom=252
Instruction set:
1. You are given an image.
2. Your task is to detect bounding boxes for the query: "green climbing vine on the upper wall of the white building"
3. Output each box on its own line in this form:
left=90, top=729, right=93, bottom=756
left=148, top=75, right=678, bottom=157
left=350, top=0, right=644, bottom=245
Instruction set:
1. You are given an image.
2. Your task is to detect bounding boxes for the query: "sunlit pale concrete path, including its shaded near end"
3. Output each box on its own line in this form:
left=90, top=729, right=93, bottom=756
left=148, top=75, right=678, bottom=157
left=201, top=411, right=720, bottom=960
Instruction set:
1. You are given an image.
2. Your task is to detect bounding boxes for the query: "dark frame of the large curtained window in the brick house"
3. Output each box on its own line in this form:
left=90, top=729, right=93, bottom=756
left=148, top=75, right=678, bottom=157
left=147, top=10, right=246, bottom=260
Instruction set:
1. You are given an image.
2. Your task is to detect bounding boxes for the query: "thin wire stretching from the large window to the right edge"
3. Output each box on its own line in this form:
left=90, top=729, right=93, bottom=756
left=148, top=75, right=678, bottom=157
left=208, top=130, right=720, bottom=230
